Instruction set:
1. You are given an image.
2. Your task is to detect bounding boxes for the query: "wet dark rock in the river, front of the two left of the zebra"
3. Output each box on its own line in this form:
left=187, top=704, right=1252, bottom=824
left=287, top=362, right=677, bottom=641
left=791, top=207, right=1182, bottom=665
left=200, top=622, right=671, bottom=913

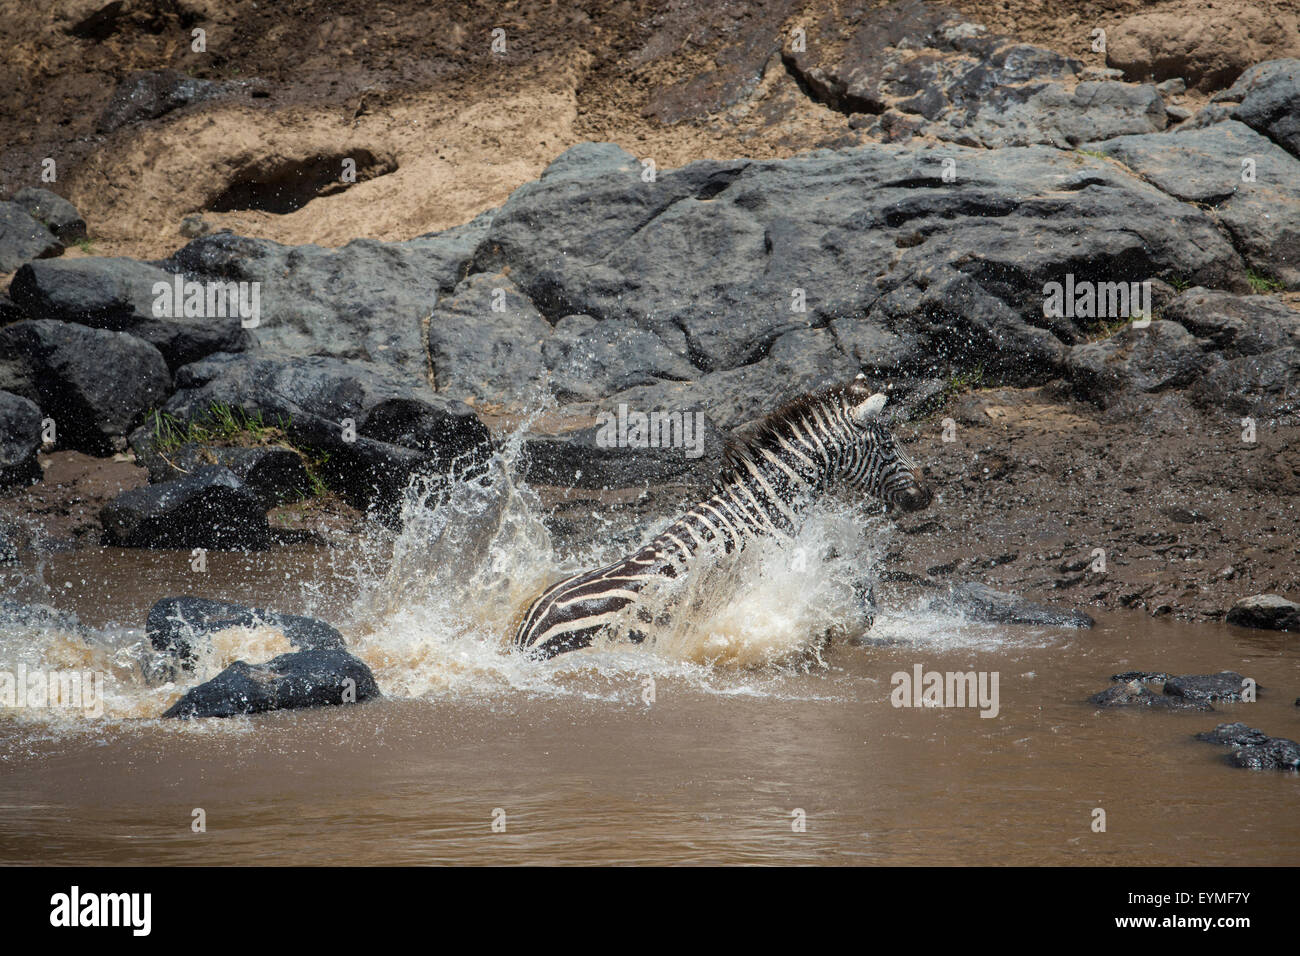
left=163, top=650, right=380, bottom=721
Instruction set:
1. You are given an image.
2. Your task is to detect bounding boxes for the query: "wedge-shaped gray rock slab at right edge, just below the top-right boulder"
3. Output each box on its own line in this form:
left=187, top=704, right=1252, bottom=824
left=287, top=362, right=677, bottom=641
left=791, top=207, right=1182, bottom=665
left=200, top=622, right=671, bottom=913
left=1093, top=121, right=1300, bottom=289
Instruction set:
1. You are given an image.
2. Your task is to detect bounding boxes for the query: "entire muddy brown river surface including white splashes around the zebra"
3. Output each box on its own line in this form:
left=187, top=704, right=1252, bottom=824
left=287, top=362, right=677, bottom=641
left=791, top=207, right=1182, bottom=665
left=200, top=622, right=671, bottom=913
left=0, top=447, right=1300, bottom=865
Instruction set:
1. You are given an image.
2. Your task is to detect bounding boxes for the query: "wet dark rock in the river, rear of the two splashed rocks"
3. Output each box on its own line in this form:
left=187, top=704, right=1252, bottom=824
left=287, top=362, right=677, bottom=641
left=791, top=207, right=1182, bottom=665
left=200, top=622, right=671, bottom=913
left=146, top=596, right=346, bottom=670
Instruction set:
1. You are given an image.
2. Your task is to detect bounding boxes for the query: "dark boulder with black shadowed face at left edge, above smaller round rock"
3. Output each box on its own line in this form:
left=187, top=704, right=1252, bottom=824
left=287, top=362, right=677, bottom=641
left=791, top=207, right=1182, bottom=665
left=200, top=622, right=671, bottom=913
left=0, top=319, right=172, bottom=455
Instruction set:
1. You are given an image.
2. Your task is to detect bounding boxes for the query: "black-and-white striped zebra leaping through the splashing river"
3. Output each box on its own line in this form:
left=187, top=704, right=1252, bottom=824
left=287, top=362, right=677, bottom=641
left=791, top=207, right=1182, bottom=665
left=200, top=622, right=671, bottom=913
left=514, top=375, right=932, bottom=659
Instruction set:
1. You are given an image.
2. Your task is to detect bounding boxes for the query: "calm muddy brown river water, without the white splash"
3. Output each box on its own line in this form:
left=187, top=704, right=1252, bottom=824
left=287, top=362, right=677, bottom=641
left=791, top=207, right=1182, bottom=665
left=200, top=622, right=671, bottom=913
left=0, top=549, right=1300, bottom=865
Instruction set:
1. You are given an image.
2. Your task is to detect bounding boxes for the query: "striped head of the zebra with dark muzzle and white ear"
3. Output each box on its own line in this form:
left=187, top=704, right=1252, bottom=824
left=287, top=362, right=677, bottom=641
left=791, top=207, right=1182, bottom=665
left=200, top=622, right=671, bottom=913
left=842, top=376, right=933, bottom=511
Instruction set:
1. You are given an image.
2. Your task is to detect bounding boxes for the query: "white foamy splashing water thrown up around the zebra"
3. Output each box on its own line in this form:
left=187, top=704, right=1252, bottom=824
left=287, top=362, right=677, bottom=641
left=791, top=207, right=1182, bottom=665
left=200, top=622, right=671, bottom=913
left=0, top=403, right=1003, bottom=722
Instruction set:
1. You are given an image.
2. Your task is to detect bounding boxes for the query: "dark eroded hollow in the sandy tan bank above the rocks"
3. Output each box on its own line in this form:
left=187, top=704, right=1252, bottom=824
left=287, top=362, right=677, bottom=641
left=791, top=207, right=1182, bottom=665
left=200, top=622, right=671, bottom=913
left=208, top=150, right=398, bottom=215
